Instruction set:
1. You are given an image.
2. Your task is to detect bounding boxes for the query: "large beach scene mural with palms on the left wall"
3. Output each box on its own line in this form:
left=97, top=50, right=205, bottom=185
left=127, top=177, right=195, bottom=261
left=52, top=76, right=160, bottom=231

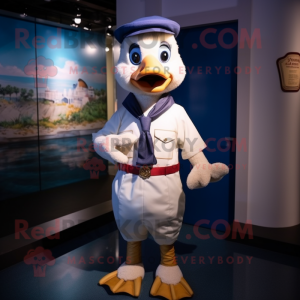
left=0, top=15, right=107, bottom=200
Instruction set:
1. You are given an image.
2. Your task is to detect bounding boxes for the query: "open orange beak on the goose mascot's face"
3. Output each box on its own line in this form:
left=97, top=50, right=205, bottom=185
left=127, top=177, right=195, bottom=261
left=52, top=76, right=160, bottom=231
left=130, top=55, right=172, bottom=93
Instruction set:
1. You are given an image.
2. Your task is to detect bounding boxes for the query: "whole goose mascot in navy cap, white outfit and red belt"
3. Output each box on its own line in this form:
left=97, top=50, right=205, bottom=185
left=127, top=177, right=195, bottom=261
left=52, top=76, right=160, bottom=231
left=93, top=16, right=228, bottom=299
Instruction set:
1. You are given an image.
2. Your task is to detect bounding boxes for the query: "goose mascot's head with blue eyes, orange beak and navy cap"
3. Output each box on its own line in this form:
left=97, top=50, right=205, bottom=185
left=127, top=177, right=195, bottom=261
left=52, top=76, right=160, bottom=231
left=115, top=17, right=186, bottom=98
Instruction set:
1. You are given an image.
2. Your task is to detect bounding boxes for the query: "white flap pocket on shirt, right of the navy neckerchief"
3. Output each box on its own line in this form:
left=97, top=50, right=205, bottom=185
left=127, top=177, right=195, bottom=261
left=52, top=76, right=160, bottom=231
left=154, top=129, right=177, bottom=159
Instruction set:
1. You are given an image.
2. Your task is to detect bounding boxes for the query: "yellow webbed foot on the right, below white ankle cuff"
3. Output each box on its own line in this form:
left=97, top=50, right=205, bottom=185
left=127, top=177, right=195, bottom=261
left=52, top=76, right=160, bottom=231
left=150, top=276, right=194, bottom=300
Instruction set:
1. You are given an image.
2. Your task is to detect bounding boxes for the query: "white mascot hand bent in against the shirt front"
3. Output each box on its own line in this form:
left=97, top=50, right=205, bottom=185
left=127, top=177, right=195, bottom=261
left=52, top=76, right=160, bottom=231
left=93, top=132, right=138, bottom=164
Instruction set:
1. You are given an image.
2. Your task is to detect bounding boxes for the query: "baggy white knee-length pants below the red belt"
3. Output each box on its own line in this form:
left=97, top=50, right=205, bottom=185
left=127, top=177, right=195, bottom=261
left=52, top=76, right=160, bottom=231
left=112, top=171, right=185, bottom=245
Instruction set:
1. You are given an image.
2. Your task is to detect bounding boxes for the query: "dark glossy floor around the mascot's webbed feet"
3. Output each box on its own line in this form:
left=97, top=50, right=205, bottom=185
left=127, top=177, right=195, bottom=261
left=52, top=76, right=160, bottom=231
left=0, top=222, right=300, bottom=300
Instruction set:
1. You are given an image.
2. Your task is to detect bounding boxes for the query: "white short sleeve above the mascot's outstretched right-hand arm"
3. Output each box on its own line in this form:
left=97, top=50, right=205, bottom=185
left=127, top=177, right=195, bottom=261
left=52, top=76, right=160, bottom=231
left=178, top=107, right=206, bottom=159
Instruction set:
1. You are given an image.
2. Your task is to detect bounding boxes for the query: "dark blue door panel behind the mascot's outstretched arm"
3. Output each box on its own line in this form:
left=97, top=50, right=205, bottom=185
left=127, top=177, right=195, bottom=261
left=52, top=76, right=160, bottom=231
left=172, top=22, right=241, bottom=230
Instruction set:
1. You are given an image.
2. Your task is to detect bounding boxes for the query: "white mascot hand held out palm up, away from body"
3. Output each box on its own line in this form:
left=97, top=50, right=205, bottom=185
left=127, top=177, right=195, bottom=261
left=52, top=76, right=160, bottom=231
left=187, top=152, right=229, bottom=190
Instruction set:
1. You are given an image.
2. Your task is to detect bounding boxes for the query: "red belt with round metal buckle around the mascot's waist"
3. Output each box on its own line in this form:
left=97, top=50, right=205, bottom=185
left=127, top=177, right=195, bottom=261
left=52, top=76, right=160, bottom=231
left=118, top=164, right=179, bottom=179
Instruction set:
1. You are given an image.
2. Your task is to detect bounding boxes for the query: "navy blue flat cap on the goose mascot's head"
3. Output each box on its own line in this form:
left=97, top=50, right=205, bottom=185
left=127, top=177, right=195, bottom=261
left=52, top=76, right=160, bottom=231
left=114, top=16, right=180, bottom=43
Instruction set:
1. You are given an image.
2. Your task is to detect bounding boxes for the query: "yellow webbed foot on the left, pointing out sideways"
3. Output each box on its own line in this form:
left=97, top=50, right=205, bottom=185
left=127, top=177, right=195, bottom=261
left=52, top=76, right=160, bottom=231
left=99, top=271, right=142, bottom=297
